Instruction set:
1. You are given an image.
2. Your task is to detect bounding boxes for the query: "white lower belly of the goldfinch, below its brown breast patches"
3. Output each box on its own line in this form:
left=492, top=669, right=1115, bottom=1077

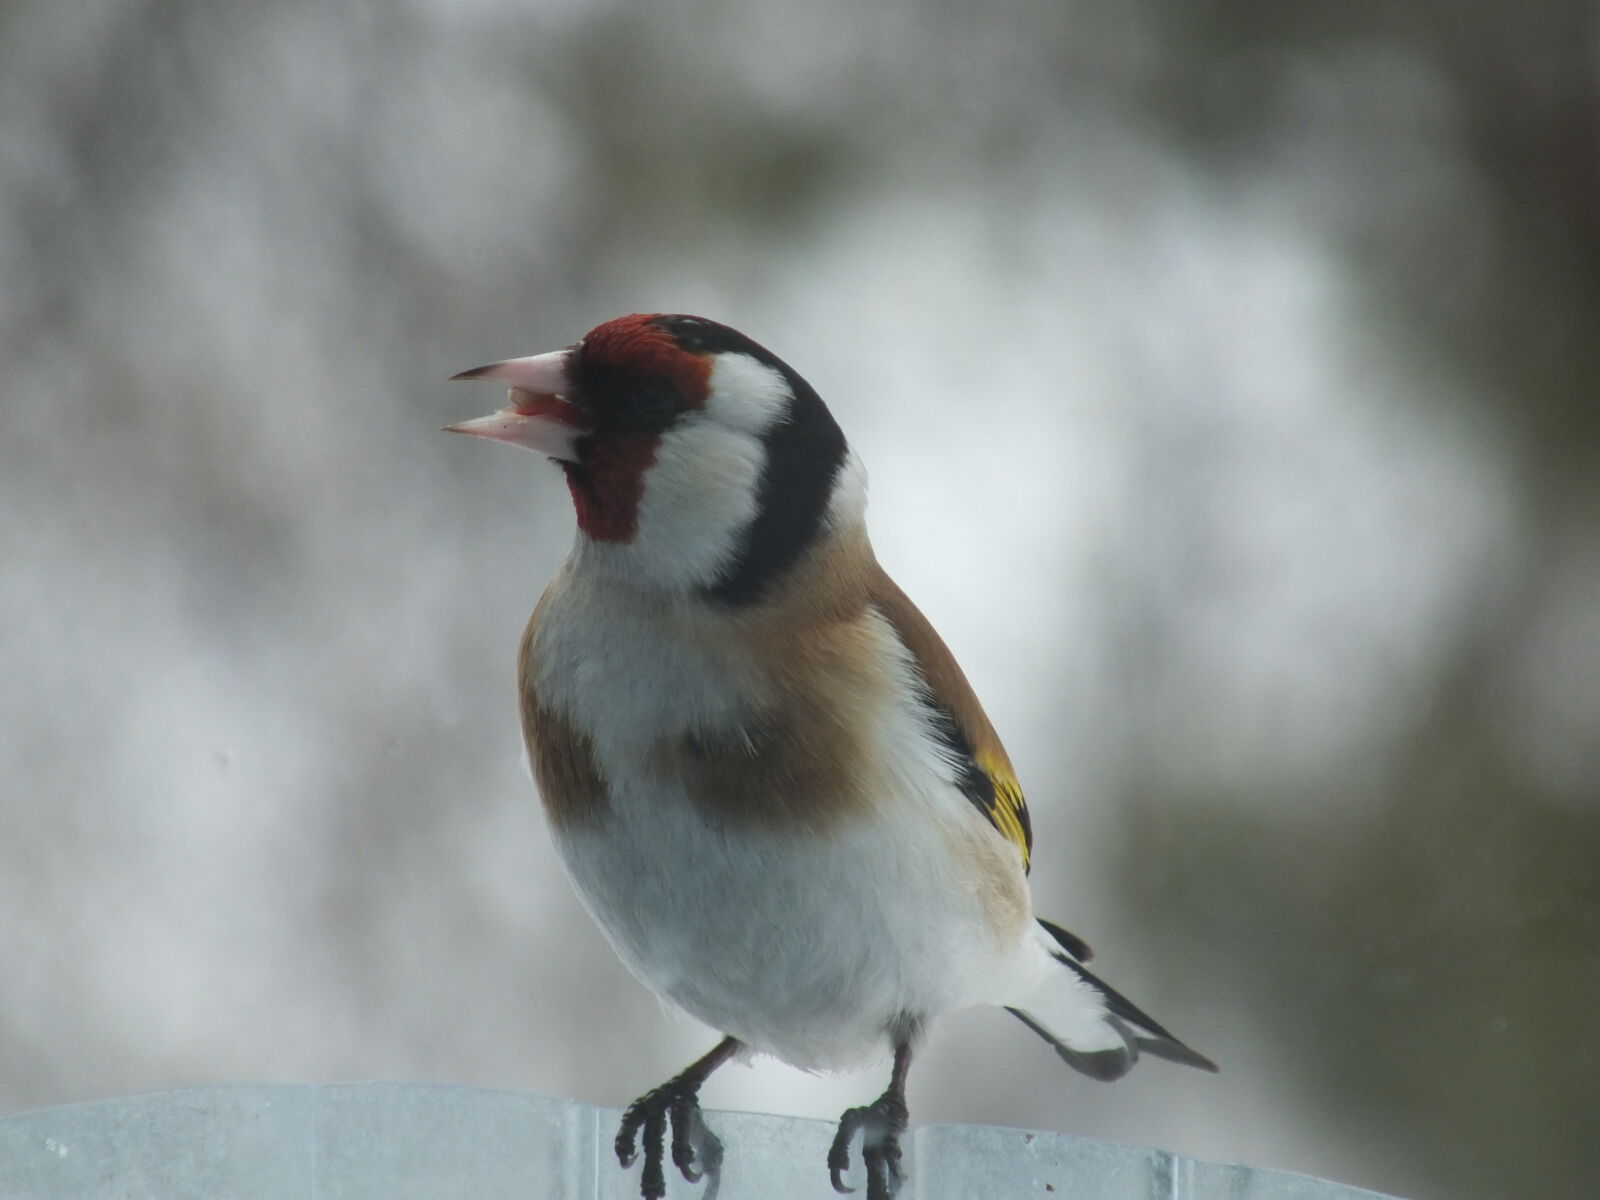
left=544, top=789, right=1003, bottom=1069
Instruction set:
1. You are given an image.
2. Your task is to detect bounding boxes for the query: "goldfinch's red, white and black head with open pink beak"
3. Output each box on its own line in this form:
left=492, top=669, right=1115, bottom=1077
left=450, top=314, right=866, bottom=606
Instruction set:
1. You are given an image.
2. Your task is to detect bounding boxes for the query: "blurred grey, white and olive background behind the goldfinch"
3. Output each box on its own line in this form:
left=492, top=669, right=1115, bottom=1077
left=0, top=0, right=1600, bottom=1200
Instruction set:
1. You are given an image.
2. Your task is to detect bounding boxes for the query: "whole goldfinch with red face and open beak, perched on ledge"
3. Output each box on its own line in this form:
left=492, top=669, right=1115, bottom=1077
left=446, top=314, right=1218, bottom=1200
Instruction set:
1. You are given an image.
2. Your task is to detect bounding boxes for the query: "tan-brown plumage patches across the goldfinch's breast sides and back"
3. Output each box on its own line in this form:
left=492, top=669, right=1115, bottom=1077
left=518, top=525, right=1030, bottom=866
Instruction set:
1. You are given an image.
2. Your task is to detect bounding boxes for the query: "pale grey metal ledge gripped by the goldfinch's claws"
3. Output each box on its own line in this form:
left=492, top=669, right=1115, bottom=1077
left=0, top=1083, right=1401, bottom=1200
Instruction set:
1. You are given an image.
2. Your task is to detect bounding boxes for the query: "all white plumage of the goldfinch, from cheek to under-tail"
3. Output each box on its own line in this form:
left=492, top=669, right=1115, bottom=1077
left=531, top=345, right=1122, bottom=1069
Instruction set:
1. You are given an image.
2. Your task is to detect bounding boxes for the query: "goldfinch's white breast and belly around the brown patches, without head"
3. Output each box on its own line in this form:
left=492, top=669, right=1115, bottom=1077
left=533, top=570, right=1027, bottom=1069
